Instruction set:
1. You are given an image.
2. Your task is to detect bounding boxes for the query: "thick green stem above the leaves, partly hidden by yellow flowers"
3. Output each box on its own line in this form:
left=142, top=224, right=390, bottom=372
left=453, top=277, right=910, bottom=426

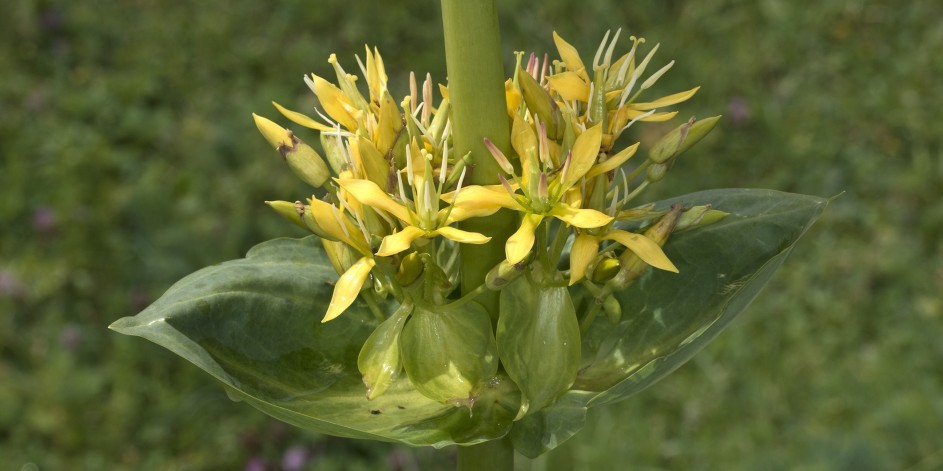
left=442, top=0, right=515, bottom=318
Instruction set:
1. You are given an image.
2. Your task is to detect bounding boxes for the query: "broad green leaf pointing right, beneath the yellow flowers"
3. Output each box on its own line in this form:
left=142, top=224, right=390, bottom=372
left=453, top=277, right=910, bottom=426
left=511, top=189, right=827, bottom=457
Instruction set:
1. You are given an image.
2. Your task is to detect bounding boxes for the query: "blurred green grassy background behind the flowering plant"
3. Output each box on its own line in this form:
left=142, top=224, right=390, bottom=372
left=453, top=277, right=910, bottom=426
left=0, top=0, right=943, bottom=470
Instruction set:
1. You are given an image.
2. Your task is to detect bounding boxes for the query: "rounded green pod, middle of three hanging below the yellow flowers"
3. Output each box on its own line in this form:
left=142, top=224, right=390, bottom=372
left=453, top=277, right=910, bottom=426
left=400, top=302, right=498, bottom=409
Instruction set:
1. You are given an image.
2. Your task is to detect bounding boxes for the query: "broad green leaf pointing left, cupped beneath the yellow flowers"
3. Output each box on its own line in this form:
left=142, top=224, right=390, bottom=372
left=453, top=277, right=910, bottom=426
left=111, top=237, right=517, bottom=447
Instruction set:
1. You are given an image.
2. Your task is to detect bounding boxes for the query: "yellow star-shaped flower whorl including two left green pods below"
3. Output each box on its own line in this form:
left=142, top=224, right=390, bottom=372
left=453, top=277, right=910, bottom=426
left=255, top=31, right=721, bottom=406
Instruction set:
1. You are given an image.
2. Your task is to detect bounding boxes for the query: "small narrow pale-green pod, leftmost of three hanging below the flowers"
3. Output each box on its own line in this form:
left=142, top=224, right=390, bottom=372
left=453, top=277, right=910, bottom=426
left=357, top=303, right=413, bottom=400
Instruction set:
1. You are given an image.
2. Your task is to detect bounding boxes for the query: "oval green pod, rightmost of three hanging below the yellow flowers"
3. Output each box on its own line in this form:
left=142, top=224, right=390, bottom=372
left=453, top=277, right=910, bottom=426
left=496, top=270, right=580, bottom=420
